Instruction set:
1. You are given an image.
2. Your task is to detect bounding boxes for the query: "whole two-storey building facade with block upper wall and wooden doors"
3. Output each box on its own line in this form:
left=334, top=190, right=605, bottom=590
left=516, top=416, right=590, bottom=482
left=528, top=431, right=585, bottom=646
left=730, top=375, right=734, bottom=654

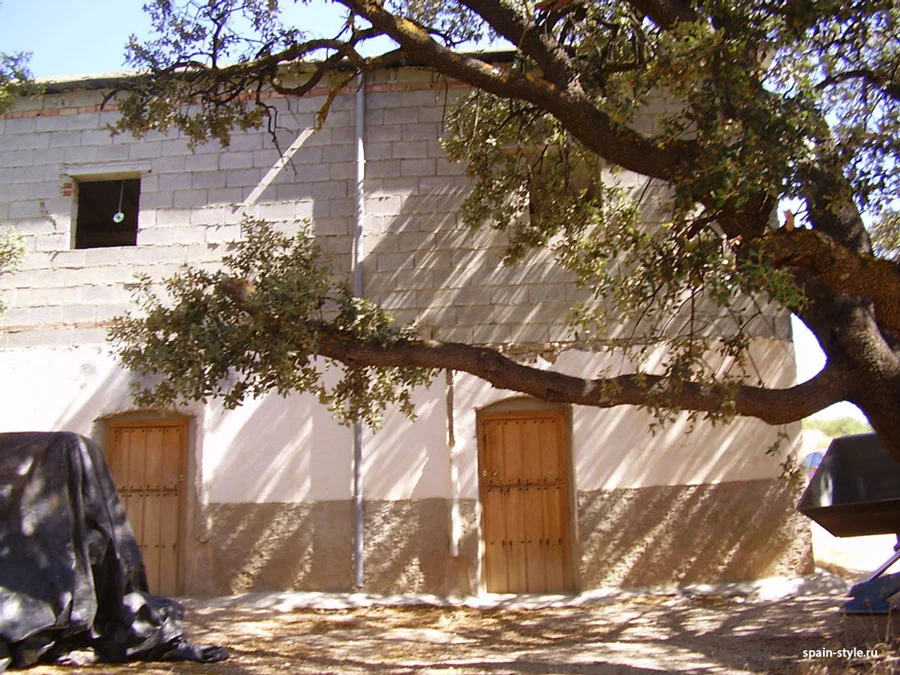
left=0, top=68, right=811, bottom=595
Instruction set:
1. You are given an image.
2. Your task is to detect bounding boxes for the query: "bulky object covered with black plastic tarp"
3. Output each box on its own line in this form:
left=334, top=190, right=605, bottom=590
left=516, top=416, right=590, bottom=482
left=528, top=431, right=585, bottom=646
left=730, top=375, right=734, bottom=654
left=0, top=432, right=227, bottom=670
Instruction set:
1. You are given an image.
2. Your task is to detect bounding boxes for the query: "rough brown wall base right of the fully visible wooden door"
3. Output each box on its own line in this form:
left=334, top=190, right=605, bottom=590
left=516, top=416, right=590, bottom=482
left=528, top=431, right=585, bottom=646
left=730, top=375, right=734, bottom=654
left=578, top=479, right=813, bottom=588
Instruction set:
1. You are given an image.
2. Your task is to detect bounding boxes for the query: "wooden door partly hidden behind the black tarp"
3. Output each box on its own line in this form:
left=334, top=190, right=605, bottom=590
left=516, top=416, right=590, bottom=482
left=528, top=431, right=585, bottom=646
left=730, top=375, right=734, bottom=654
left=106, top=420, right=187, bottom=595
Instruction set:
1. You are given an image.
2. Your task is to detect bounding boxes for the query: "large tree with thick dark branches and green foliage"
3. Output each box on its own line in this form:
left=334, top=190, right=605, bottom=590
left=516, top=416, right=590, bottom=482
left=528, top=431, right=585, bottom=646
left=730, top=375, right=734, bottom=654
left=107, top=0, right=900, bottom=453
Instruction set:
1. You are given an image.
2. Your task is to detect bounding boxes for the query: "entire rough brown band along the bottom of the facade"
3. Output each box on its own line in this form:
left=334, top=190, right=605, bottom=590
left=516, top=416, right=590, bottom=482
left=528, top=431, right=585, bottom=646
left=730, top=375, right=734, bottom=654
left=199, top=480, right=813, bottom=595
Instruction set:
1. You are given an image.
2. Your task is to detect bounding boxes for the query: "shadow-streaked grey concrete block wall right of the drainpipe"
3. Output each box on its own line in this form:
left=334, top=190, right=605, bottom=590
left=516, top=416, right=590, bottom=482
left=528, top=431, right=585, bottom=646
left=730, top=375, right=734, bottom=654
left=364, top=73, right=588, bottom=344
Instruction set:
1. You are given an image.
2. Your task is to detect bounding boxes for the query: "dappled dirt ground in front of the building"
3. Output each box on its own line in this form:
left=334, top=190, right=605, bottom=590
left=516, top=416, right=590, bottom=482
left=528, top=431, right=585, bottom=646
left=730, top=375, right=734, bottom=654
left=29, top=575, right=900, bottom=675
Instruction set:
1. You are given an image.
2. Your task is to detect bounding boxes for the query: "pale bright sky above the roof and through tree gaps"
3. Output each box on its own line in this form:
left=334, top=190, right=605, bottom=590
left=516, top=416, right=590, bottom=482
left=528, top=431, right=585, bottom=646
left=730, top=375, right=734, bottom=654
left=0, top=0, right=860, bottom=416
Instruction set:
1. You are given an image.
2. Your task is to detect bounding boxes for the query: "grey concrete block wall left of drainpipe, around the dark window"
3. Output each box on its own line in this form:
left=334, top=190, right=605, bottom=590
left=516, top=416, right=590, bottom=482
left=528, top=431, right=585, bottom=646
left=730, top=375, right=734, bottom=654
left=0, top=80, right=355, bottom=348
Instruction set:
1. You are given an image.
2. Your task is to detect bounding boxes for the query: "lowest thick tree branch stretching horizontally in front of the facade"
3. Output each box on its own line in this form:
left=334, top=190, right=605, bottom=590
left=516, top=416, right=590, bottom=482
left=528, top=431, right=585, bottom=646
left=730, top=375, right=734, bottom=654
left=317, top=333, right=847, bottom=424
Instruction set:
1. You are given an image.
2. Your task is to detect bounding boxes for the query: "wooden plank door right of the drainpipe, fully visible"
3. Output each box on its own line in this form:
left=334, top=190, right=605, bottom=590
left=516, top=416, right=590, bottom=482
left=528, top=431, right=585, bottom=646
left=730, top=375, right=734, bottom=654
left=478, top=411, right=575, bottom=593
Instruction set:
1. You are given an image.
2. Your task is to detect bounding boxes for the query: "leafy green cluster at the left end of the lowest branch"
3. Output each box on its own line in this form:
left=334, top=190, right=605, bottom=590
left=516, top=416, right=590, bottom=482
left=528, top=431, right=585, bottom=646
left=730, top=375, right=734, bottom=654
left=110, top=218, right=432, bottom=425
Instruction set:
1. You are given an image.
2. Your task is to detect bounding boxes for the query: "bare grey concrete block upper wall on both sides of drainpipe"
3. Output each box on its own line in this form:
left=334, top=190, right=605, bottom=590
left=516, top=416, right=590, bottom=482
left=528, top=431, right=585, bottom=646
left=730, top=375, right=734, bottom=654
left=0, top=69, right=592, bottom=354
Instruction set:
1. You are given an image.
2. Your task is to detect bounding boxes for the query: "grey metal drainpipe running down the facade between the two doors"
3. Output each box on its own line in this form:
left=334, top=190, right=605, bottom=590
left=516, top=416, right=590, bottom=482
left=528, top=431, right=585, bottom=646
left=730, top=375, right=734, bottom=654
left=351, top=73, right=366, bottom=589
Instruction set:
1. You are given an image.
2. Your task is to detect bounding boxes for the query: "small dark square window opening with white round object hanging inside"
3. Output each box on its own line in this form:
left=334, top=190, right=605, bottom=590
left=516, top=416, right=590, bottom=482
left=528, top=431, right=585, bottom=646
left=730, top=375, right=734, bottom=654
left=75, top=178, right=141, bottom=248
